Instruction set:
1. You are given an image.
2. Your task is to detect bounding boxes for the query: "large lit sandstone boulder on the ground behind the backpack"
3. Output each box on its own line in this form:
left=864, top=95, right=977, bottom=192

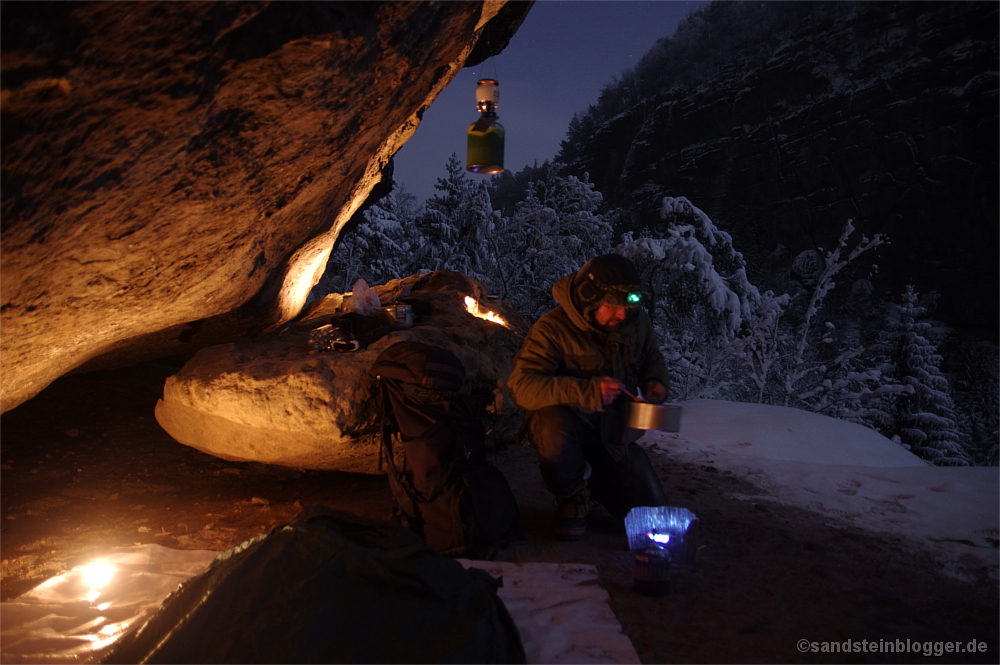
left=156, top=271, right=528, bottom=473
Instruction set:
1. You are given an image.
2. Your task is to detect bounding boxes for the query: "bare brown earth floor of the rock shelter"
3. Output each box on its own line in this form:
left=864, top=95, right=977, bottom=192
left=0, top=364, right=1000, bottom=663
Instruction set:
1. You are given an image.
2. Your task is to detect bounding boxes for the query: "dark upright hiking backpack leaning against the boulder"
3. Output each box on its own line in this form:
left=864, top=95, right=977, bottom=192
left=369, top=342, right=519, bottom=559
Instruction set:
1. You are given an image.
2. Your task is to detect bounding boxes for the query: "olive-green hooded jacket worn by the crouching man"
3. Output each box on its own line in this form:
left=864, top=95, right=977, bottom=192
left=507, top=275, right=669, bottom=413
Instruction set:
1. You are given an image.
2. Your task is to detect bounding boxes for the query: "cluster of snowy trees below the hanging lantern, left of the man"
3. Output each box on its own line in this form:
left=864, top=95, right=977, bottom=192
left=314, top=161, right=612, bottom=318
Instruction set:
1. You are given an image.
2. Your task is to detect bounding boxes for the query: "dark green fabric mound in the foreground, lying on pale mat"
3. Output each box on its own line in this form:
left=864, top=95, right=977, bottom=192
left=104, top=507, right=526, bottom=663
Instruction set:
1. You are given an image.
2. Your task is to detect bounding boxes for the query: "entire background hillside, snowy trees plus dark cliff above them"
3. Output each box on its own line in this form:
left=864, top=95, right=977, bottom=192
left=313, top=2, right=1000, bottom=466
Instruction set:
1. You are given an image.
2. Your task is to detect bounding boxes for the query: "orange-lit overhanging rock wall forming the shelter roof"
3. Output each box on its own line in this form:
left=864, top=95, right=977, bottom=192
left=0, top=1, right=530, bottom=410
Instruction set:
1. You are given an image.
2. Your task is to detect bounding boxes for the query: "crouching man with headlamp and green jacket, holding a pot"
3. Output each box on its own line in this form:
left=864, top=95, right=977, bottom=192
left=507, top=254, right=668, bottom=540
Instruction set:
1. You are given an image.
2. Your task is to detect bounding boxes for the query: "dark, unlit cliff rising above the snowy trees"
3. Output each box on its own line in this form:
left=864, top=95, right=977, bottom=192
left=563, top=2, right=1000, bottom=335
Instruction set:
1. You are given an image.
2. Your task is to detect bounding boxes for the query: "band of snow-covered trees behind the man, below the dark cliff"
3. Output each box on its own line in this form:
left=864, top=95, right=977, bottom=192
left=312, top=156, right=1000, bottom=466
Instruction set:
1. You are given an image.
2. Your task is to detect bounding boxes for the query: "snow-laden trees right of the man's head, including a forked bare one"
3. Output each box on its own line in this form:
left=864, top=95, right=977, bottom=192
left=616, top=208, right=909, bottom=424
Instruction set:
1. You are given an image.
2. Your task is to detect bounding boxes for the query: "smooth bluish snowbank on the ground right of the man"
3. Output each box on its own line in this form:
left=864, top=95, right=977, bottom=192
left=640, top=400, right=1000, bottom=578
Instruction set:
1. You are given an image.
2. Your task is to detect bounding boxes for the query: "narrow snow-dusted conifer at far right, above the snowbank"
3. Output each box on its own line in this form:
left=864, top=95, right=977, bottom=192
left=878, top=286, right=971, bottom=466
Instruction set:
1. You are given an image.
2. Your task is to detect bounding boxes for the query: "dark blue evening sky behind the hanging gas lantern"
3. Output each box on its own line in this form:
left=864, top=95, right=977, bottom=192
left=395, top=0, right=709, bottom=202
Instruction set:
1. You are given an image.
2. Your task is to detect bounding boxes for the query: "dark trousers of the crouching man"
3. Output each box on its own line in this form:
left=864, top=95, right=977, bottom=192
left=527, top=405, right=667, bottom=517
